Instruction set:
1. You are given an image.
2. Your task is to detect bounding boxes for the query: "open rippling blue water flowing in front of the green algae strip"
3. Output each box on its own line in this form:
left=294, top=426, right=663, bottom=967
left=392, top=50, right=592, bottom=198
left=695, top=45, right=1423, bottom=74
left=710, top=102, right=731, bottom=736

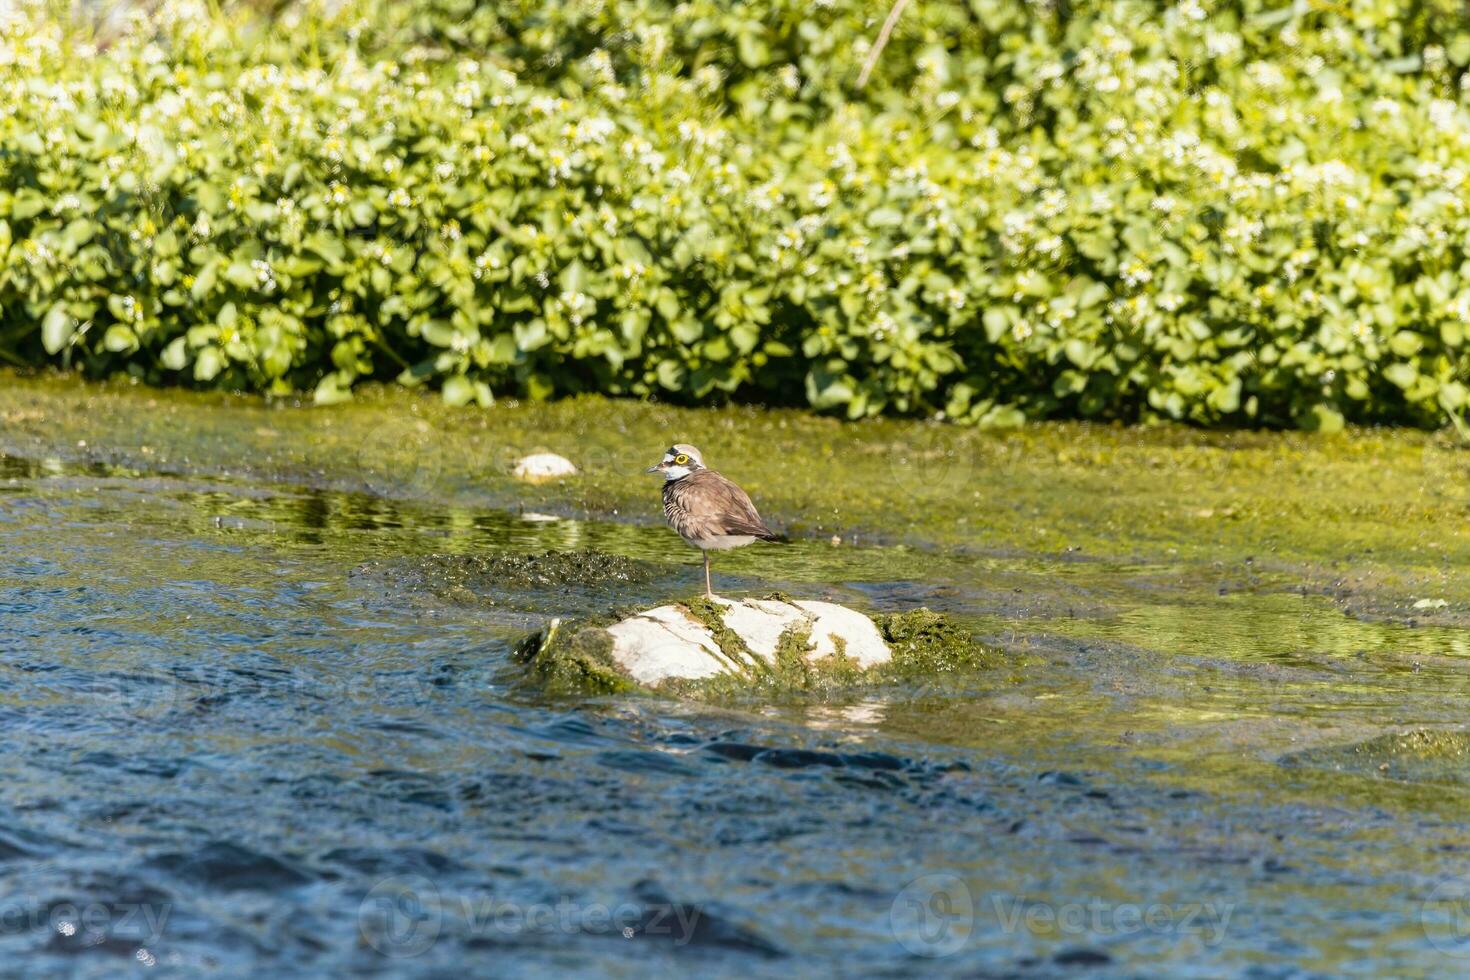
left=0, top=458, right=1470, bottom=976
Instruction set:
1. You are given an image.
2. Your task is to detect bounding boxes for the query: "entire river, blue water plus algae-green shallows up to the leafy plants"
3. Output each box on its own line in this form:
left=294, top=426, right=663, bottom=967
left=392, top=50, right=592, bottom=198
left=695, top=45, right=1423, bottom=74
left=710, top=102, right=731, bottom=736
left=0, top=376, right=1470, bottom=976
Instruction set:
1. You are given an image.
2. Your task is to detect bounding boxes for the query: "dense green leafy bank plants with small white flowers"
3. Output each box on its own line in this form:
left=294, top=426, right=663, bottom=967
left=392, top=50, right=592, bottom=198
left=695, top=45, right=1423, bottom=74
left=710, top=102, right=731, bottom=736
left=0, top=0, right=1470, bottom=429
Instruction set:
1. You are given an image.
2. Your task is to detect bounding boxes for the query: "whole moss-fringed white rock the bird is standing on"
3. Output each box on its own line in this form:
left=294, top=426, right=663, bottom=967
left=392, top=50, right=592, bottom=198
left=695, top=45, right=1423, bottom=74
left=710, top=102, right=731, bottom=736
left=516, top=595, right=997, bottom=696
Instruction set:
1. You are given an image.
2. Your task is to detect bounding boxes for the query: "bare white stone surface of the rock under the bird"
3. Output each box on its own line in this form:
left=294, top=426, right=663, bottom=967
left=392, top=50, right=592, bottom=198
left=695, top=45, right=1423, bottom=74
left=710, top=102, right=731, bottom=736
left=607, top=598, right=892, bottom=686
